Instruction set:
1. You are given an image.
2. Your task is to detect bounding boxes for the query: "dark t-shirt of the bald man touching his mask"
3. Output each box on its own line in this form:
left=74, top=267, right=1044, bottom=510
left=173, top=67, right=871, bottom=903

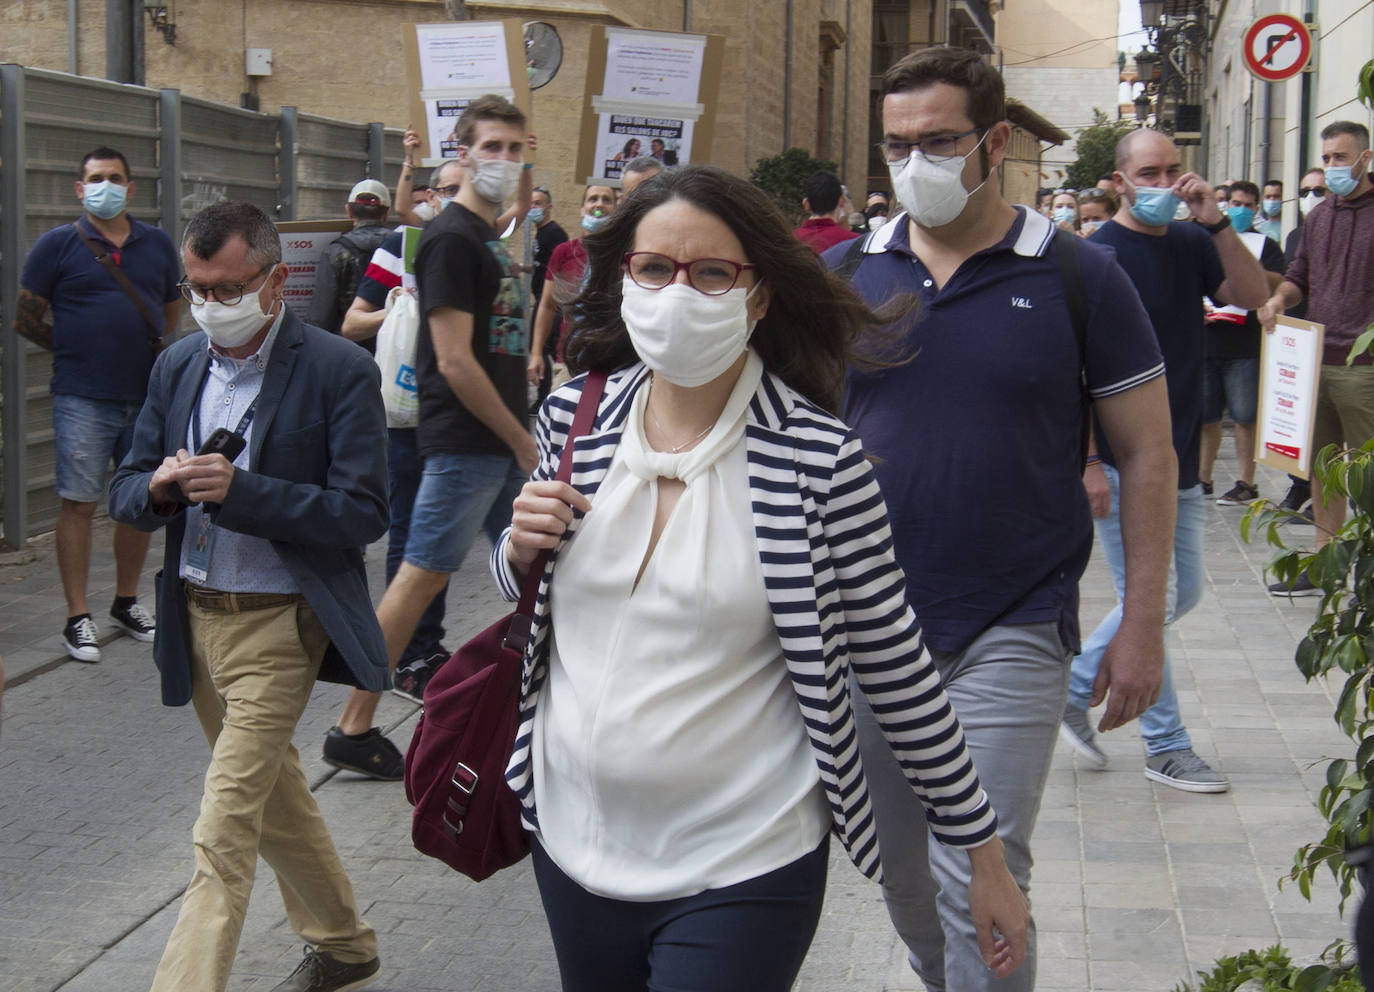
left=1091, top=220, right=1226, bottom=489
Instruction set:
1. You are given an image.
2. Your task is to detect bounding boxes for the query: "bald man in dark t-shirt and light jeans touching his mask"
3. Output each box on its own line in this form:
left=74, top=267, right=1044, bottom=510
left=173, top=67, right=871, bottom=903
left=1062, top=128, right=1268, bottom=793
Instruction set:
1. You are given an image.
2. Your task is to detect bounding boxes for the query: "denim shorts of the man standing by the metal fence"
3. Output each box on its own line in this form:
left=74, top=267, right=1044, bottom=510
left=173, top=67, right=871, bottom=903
left=52, top=393, right=143, bottom=503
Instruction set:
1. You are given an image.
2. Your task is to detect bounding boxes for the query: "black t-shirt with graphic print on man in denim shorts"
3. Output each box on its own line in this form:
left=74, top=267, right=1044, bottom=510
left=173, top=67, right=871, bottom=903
left=415, top=203, right=529, bottom=455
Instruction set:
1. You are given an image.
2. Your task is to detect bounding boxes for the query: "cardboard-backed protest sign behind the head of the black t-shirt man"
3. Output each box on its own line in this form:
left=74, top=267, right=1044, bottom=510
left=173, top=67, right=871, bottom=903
left=401, top=21, right=530, bottom=166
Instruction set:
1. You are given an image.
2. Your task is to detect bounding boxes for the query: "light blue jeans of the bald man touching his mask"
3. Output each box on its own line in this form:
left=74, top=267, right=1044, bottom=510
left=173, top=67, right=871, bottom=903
left=1069, top=464, right=1206, bottom=754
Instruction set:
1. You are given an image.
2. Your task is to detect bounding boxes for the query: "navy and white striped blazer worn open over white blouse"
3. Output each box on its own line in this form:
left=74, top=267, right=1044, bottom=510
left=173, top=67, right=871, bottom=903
left=491, top=364, right=996, bottom=879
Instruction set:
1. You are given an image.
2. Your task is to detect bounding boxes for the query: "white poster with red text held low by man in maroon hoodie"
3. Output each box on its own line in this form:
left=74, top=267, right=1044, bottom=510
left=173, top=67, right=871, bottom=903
left=1254, top=316, right=1326, bottom=478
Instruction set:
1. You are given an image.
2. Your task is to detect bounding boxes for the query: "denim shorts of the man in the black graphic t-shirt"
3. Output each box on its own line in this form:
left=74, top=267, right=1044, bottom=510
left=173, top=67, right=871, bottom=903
left=405, top=452, right=525, bottom=573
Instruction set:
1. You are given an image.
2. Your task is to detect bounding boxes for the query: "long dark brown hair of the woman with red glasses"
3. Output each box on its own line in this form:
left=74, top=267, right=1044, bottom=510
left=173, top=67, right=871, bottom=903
left=566, top=165, right=890, bottom=414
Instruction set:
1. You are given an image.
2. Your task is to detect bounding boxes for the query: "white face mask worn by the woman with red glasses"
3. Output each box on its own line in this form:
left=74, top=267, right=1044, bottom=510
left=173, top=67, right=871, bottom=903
left=620, top=275, right=758, bottom=387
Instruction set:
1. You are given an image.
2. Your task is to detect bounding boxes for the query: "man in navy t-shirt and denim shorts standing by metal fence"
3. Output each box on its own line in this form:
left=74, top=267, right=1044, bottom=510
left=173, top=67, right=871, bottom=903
left=15, top=147, right=181, bottom=662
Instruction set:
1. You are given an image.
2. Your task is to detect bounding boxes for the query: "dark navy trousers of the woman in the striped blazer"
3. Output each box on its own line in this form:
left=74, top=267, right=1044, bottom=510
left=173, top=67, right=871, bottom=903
left=530, top=837, right=830, bottom=992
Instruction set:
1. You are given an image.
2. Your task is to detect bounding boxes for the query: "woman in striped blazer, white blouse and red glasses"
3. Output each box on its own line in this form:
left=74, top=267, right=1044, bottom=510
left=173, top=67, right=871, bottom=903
left=492, top=166, right=1029, bottom=992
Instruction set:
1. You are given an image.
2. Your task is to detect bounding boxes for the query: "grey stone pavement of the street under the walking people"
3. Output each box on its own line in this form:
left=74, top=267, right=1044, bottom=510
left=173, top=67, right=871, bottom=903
left=0, top=442, right=1348, bottom=992
